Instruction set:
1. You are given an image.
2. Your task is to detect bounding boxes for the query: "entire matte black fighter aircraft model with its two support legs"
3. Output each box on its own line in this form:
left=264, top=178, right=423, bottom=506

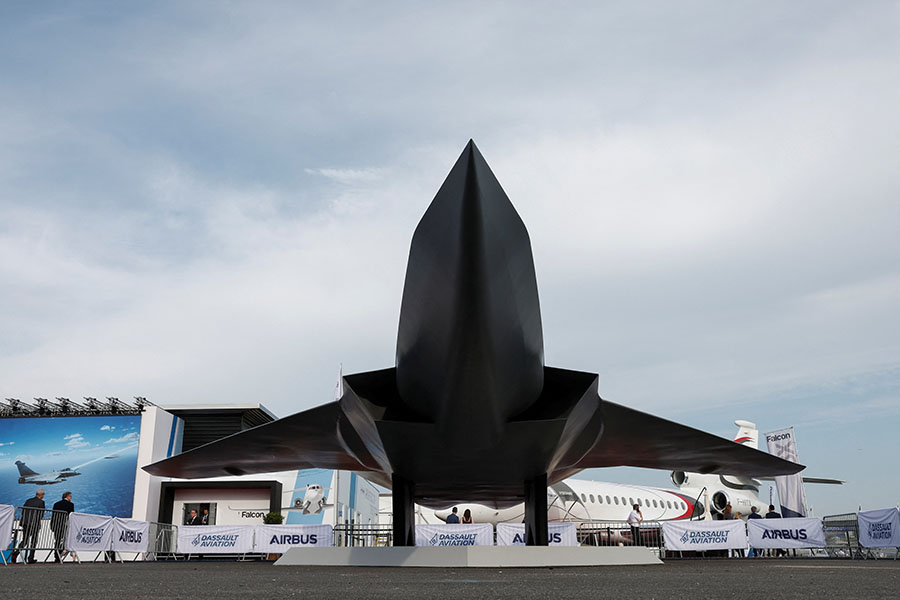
left=144, top=140, right=803, bottom=546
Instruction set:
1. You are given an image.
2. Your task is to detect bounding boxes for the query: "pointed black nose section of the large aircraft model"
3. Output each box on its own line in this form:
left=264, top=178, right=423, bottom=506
left=396, top=142, right=544, bottom=453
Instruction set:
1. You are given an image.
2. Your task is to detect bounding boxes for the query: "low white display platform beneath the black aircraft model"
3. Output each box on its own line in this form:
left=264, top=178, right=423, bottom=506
left=275, top=546, right=663, bottom=568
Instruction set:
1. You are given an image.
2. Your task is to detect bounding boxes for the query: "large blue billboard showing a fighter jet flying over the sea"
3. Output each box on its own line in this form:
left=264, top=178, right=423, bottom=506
left=0, top=415, right=141, bottom=517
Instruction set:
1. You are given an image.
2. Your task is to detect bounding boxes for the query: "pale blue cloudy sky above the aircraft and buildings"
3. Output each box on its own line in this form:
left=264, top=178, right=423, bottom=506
left=0, top=1, right=900, bottom=514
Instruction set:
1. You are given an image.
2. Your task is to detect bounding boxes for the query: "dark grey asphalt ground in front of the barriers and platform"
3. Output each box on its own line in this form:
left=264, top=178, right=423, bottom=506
left=0, top=559, right=900, bottom=600
